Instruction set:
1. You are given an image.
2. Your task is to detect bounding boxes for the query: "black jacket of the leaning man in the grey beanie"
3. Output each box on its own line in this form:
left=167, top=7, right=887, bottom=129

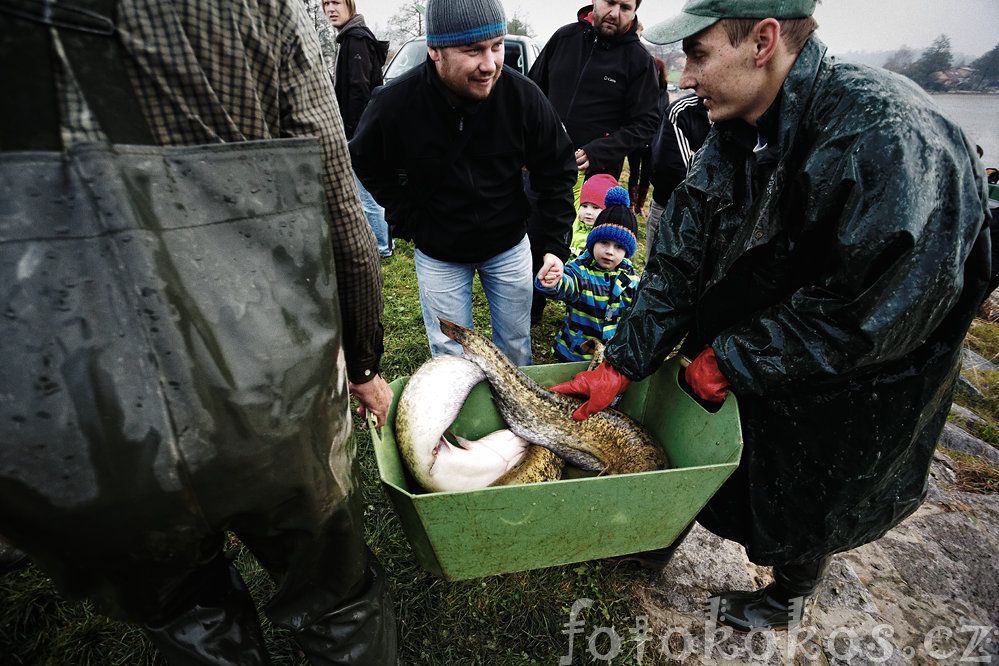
left=350, top=59, right=576, bottom=263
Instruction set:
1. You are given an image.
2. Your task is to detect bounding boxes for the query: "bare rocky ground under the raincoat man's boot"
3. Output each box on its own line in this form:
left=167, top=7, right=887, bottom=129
left=639, top=352, right=999, bottom=666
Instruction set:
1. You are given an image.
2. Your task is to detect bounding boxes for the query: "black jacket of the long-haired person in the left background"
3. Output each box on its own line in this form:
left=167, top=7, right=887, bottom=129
left=333, top=14, right=389, bottom=139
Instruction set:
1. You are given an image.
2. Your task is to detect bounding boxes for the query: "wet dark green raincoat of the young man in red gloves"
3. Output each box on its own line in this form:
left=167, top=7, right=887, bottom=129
left=606, top=37, right=989, bottom=564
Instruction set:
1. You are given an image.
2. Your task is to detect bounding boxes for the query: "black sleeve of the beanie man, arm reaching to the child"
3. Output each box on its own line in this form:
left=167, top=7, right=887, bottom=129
left=524, top=86, right=578, bottom=261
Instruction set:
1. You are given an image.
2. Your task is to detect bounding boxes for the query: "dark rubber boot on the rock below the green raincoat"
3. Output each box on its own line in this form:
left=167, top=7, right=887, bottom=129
left=708, top=557, right=829, bottom=633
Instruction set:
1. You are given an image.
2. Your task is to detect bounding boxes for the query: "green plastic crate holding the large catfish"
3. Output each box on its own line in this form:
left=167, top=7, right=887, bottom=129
left=371, top=357, right=742, bottom=580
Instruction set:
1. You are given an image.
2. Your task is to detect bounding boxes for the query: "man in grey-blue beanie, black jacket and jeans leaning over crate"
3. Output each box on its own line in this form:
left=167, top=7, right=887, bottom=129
left=350, top=0, right=575, bottom=365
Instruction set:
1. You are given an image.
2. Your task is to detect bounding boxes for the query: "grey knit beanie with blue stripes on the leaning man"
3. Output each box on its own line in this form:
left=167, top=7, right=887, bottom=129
left=427, top=0, right=506, bottom=48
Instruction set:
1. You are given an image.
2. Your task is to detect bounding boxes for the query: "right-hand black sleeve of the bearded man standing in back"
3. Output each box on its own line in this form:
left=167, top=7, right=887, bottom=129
left=581, top=57, right=659, bottom=172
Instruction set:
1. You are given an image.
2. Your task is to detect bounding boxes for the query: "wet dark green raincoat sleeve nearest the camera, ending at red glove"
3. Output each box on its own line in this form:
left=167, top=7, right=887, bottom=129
left=712, top=114, right=988, bottom=395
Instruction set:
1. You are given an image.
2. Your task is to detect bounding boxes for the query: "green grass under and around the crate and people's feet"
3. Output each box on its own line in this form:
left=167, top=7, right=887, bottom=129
left=0, top=197, right=999, bottom=666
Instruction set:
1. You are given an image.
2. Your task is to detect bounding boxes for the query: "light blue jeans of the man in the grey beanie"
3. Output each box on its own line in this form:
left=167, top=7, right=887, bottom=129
left=415, top=236, right=534, bottom=365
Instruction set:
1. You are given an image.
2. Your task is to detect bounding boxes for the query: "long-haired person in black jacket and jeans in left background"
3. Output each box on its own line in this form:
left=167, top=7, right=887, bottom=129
left=323, top=0, right=393, bottom=258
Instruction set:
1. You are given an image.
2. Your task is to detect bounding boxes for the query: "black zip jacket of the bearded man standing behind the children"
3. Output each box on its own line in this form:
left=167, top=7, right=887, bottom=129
left=530, top=6, right=659, bottom=177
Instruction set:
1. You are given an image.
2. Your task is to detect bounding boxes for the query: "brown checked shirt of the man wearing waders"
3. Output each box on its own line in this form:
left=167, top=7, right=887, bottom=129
left=117, top=0, right=382, bottom=383
